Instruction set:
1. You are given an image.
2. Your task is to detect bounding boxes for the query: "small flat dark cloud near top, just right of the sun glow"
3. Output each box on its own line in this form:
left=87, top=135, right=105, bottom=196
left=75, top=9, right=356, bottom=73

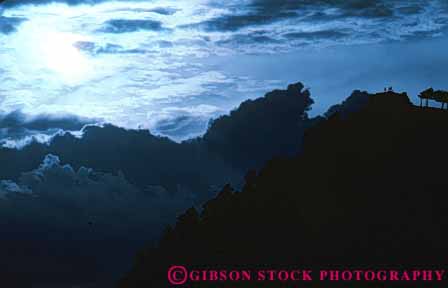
left=99, top=19, right=163, bottom=33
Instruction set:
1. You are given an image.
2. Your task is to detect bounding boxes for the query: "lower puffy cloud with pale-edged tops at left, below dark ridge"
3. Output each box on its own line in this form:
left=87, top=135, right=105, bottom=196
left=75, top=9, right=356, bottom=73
left=0, top=154, right=192, bottom=229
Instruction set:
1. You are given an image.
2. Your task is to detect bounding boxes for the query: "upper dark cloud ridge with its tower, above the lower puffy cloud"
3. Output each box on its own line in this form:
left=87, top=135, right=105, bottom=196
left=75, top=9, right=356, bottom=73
left=0, top=84, right=312, bottom=195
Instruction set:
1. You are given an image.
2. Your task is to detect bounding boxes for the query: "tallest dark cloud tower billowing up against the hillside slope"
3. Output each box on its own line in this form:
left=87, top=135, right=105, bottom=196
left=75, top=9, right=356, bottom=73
left=203, top=82, right=314, bottom=167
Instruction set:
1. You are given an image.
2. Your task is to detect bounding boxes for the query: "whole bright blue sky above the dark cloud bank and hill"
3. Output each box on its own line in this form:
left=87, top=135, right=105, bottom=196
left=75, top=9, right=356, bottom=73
left=0, top=0, right=448, bottom=140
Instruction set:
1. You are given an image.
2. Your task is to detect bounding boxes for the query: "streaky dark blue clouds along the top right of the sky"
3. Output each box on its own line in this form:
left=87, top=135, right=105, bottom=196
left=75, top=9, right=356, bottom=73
left=187, top=0, right=448, bottom=48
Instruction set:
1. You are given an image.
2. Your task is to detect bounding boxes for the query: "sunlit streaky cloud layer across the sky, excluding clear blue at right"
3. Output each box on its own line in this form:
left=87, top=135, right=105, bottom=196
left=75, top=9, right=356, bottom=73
left=0, top=0, right=448, bottom=146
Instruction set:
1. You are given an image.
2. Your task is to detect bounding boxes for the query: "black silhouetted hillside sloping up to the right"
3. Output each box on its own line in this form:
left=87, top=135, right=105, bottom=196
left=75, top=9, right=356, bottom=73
left=118, top=91, right=448, bottom=288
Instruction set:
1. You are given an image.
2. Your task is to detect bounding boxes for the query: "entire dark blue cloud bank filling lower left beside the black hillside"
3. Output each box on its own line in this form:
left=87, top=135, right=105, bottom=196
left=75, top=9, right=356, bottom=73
left=0, top=83, right=318, bottom=287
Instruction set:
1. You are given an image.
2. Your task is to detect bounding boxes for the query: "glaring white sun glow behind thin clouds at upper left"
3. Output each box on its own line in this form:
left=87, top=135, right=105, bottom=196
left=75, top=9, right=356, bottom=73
left=4, top=16, right=94, bottom=85
